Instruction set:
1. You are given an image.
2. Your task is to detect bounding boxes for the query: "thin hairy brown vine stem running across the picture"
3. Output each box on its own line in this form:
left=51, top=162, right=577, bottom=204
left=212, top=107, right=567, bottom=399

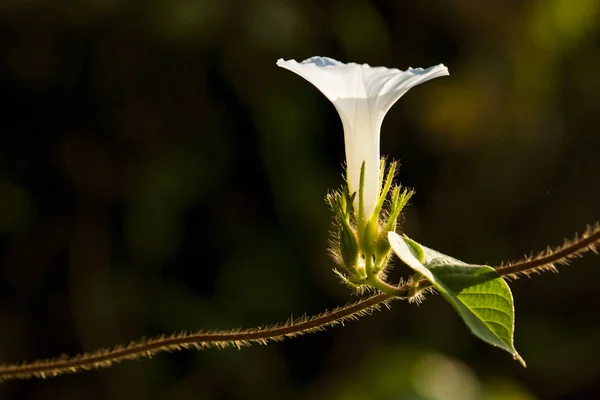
left=0, top=224, right=600, bottom=382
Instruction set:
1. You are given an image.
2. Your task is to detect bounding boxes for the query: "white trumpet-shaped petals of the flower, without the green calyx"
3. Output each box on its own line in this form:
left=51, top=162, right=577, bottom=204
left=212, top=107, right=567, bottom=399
left=277, top=57, right=448, bottom=220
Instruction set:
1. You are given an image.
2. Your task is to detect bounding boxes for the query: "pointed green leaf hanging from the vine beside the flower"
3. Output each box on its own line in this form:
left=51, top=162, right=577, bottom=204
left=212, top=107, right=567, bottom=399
left=388, top=232, right=526, bottom=366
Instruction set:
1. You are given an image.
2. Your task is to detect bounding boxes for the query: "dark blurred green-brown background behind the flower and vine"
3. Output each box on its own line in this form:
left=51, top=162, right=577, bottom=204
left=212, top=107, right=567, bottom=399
left=0, top=0, right=600, bottom=400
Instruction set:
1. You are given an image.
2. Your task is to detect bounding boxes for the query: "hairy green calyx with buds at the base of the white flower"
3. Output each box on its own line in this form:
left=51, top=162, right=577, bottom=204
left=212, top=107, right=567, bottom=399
left=326, top=160, right=414, bottom=294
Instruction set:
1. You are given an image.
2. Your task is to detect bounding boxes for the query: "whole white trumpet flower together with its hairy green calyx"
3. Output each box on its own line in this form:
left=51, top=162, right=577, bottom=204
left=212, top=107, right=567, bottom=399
left=277, top=57, right=448, bottom=292
